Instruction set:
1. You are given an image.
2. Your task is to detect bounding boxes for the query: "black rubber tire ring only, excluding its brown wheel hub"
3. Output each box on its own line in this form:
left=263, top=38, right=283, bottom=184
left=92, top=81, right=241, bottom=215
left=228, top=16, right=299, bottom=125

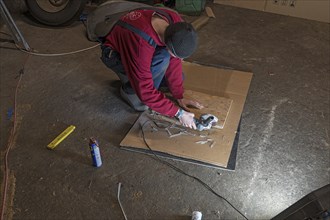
left=25, top=0, right=87, bottom=26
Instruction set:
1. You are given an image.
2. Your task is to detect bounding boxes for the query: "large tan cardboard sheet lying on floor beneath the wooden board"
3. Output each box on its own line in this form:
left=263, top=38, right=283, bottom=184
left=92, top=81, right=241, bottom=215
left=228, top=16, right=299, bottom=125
left=120, top=62, right=252, bottom=168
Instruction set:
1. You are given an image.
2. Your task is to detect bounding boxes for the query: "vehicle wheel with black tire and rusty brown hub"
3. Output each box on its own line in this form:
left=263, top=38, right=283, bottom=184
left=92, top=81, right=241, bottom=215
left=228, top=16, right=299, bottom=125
left=25, top=0, right=87, bottom=26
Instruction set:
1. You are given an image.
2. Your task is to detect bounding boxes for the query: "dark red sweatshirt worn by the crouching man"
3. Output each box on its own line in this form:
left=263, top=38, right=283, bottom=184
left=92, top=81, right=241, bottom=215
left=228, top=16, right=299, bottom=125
left=104, top=9, right=183, bottom=117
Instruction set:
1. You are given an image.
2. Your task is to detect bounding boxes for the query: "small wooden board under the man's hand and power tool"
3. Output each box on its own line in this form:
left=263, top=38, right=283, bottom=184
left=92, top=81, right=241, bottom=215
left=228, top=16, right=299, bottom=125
left=184, top=90, right=233, bottom=129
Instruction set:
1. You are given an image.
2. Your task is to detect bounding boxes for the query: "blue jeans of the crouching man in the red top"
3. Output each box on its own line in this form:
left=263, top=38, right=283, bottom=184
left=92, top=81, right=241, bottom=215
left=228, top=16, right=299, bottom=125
left=101, top=45, right=170, bottom=93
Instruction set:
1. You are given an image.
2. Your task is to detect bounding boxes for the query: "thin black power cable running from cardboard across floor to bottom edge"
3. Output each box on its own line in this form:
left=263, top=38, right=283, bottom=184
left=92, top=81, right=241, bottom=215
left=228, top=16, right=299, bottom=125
left=141, top=120, right=248, bottom=220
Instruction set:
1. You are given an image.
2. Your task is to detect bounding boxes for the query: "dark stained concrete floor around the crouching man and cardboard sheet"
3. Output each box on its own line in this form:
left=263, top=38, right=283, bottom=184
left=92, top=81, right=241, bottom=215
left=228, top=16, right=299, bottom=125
left=0, top=1, right=330, bottom=220
